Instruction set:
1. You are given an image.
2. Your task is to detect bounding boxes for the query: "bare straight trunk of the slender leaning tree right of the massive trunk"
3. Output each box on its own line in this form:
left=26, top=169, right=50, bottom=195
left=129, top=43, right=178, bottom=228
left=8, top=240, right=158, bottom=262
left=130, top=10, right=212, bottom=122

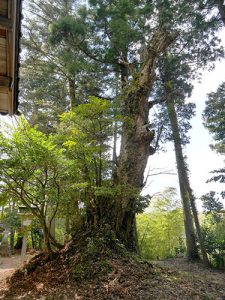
left=166, top=99, right=199, bottom=260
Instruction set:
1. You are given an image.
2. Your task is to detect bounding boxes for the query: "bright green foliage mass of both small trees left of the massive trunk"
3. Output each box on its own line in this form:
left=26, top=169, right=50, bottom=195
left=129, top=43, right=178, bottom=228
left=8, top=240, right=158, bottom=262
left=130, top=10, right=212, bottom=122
left=0, top=97, right=115, bottom=245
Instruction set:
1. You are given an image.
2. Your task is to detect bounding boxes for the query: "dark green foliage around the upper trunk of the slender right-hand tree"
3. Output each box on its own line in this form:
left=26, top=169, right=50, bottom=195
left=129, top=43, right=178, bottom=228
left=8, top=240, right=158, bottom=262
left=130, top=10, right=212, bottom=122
left=152, top=53, right=195, bottom=145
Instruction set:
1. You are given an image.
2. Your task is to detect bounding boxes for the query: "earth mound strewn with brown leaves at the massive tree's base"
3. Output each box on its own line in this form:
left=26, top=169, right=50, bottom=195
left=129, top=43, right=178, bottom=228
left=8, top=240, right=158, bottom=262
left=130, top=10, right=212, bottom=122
left=0, top=252, right=225, bottom=300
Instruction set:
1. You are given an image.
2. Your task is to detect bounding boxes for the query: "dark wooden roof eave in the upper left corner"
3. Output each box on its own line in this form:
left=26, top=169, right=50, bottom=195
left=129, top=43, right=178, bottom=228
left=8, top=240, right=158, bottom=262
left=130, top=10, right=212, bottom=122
left=0, top=0, right=22, bottom=115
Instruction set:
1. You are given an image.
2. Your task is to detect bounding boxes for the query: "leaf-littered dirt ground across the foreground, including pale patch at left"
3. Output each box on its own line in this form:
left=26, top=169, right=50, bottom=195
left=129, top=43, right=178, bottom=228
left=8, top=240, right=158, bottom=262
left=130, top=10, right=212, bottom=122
left=0, top=256, right=225, bottom=300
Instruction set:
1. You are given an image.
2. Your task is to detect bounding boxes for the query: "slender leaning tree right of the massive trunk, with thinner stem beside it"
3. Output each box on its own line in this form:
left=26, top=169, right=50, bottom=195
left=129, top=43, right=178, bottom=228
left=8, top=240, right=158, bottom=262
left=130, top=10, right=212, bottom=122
left=155, top=53, right=213, bottom=265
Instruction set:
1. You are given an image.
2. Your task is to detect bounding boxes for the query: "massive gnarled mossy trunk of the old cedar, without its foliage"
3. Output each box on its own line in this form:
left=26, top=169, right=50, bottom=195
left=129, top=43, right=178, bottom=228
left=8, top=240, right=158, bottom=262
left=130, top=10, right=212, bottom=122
left=110, top=28, right=177, bottom=251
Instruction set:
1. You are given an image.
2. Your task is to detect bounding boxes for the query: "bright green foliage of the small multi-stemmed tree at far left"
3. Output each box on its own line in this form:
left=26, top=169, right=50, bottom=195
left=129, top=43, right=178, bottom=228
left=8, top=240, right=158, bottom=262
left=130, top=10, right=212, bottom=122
left=0, top=118, right=70, bottom=216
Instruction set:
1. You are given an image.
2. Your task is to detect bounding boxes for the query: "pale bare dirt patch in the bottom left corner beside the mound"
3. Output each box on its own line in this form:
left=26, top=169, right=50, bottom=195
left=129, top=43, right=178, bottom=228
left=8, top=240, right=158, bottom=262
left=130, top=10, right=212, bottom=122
left=0, top=254, right=32, bottom=299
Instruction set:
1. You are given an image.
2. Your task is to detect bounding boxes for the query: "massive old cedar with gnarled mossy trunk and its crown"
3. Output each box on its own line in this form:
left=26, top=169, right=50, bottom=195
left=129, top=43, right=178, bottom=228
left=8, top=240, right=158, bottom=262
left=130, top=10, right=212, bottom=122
left=20, top=0, right=223, bottom=250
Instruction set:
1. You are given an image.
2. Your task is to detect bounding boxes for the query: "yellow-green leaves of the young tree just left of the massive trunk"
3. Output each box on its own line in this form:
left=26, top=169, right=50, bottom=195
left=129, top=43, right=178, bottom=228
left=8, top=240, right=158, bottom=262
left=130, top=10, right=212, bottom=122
left=56, top=97, right=113, bottom=190
